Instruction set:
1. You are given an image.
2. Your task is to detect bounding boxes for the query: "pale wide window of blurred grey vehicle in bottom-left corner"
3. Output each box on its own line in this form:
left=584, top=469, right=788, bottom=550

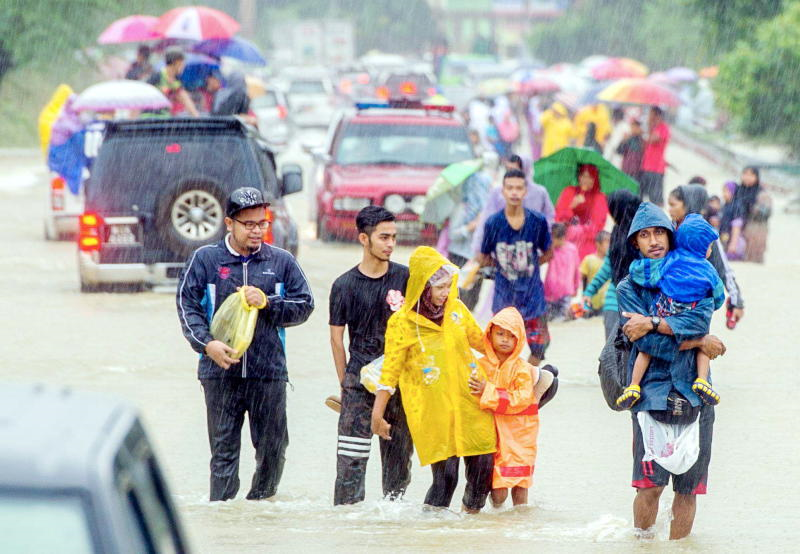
left=0, top=490, right=96, bottom=554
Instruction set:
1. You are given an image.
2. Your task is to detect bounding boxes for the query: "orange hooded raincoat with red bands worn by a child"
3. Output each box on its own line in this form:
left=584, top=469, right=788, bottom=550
left=478, top=308, right=539, bottom=489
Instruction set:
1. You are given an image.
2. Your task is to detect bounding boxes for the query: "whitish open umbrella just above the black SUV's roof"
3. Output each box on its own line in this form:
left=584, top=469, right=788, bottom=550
left=73, top=79, right=171, bottom=112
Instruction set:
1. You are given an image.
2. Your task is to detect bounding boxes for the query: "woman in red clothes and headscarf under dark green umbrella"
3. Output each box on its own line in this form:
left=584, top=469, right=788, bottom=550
left=556, top=164, right=608, bottom=259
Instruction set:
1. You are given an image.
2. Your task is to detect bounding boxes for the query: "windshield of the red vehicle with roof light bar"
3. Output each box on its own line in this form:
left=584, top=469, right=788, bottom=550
left=335, top=123, right=473, bottom=166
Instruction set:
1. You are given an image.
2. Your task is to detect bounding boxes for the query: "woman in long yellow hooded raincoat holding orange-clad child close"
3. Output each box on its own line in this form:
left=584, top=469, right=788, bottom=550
left=372, top=246, right=497, bottom=512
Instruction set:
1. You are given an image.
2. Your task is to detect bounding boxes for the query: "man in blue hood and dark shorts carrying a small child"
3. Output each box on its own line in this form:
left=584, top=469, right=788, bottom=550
left=617, top=202, right=725, bottom=539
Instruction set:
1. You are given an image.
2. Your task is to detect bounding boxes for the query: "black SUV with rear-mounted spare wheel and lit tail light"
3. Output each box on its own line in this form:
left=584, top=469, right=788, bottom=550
left=78, top=117, right=303, bottom=292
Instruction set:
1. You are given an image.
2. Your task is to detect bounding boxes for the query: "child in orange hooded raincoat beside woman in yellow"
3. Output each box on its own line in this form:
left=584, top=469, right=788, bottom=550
left=470, top=308, right=555, bottom=508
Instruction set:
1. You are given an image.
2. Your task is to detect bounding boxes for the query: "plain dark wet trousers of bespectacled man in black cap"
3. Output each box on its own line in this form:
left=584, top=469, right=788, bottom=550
left=200, top=377, right=289, bottom=501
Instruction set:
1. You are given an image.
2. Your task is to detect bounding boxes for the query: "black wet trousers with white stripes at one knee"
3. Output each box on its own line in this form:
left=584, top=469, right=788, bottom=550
left=333, top=373, right=414, bottom=505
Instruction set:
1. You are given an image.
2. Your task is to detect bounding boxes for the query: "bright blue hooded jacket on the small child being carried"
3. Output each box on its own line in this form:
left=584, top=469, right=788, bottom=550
left=630, top=214, right=725, bottom=310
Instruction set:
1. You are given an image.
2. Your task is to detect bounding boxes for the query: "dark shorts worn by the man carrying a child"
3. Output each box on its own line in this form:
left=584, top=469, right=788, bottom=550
left=631, top=406, right=714, bottom=494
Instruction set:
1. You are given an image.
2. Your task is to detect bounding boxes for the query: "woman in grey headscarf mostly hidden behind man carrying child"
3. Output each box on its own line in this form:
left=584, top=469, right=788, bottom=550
left=667, top=185, right=744, bottom=329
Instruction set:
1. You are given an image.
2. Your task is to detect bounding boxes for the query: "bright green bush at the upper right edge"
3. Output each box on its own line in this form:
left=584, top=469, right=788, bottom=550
left=715, top=2, right=800, bottom=149
